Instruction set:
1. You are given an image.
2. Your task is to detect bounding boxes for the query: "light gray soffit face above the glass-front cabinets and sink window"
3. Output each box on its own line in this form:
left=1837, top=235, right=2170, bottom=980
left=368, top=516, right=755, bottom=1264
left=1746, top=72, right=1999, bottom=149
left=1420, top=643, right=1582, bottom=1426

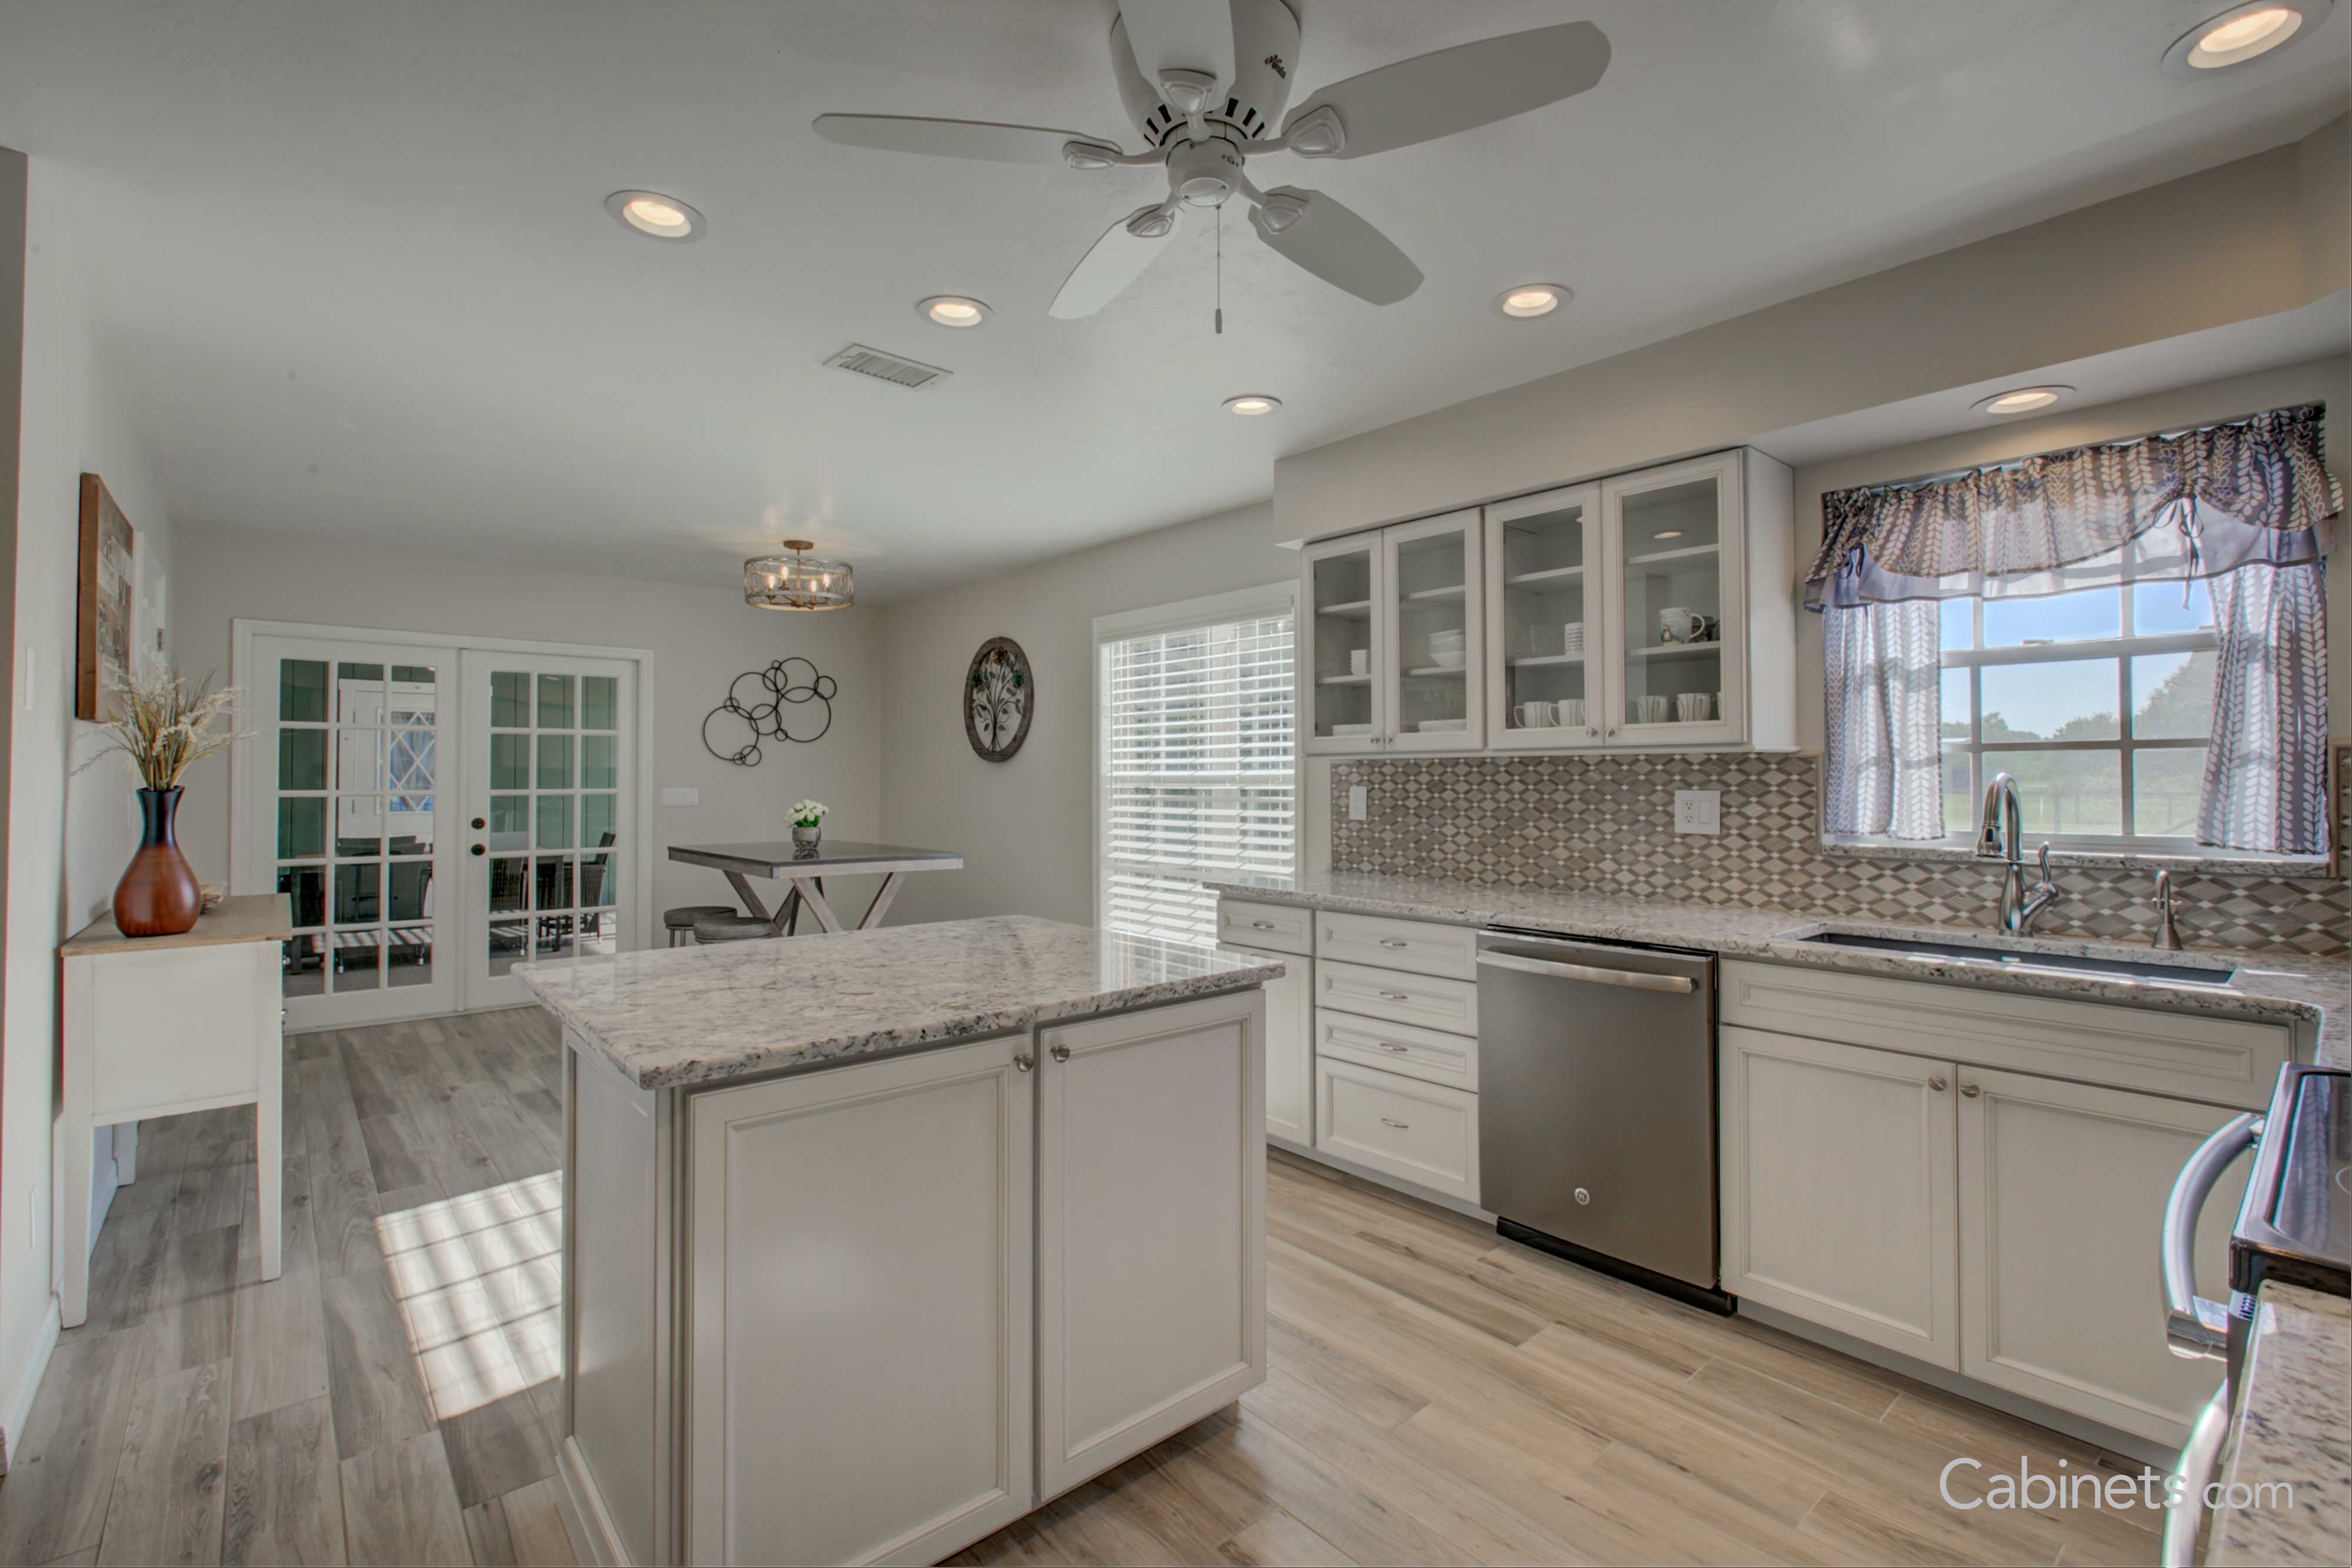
left=1272, top=118, right=2352, bottom=541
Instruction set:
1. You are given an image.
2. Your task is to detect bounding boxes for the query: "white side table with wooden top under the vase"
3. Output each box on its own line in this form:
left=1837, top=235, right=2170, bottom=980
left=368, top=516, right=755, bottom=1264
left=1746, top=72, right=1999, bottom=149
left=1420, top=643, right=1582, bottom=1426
left=56, top=893, right=294, bottom=1328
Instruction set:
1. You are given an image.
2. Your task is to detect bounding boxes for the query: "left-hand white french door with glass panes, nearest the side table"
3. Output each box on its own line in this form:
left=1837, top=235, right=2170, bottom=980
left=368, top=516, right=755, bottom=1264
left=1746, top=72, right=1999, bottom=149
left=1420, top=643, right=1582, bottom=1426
left=249, top=637, right=454, bottom=1027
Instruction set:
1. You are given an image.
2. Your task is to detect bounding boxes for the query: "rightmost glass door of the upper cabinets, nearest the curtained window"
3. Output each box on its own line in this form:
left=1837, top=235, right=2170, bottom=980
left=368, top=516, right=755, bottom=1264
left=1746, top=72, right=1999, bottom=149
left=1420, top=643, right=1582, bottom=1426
left=1599, top=456, right=1743, bottom=745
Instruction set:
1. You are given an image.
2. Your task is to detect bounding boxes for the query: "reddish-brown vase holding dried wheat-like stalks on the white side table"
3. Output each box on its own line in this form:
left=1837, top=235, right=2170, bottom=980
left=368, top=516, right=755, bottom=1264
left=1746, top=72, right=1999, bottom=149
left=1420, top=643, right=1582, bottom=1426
left=82, top=663, right=245, bottom=935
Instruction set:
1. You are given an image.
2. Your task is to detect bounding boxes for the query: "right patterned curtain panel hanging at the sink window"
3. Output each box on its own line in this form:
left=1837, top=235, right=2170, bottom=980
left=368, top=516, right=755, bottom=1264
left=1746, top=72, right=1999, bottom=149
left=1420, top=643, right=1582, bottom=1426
left=2197, top=567, right=2328, bottom=855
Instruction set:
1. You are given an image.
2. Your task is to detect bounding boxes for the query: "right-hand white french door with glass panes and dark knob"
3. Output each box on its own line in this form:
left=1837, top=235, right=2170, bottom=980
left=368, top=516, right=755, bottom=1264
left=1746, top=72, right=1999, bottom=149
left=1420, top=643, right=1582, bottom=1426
left=463, top=649, right=637, bottom=1006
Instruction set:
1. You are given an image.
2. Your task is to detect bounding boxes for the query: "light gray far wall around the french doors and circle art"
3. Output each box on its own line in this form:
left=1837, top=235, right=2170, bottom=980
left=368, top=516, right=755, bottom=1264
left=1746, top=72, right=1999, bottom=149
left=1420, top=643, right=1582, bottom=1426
left=174, top=529, right=884, bottom=940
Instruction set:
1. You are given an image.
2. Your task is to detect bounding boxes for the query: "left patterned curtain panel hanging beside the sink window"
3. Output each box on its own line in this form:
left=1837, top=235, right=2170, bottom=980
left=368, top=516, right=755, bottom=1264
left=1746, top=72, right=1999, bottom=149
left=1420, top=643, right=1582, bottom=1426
left=1820, top=600, right=1947, bottom=839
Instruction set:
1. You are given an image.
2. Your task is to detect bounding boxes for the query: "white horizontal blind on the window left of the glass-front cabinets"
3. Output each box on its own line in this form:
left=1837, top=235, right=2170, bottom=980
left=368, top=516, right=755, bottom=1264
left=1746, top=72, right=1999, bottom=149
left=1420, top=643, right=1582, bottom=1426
left=1096, top=590, right=1296, bottom=942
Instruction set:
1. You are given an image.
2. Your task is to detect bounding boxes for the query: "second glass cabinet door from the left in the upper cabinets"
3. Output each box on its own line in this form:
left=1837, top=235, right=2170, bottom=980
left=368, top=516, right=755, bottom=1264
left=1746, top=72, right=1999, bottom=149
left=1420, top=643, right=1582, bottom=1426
left=1381, top=510, right=1486, bottom=753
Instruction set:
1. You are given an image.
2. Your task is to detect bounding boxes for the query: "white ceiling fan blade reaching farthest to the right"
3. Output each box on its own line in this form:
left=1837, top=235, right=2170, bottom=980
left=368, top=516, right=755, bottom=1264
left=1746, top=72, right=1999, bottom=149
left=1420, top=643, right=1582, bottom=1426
left=1282, top=21, right=1609, bottom=158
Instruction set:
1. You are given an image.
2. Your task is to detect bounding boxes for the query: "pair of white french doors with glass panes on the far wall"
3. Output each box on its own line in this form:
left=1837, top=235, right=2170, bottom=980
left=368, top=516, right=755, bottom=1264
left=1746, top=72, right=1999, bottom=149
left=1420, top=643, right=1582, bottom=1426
left=246, top=628, right=644, bottom=1029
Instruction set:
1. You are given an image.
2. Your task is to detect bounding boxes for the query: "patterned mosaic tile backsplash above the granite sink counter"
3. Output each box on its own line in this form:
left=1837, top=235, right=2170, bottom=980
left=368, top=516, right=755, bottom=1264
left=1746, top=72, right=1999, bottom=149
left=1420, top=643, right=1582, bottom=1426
left=1331, top=755, right=2352, bottom=957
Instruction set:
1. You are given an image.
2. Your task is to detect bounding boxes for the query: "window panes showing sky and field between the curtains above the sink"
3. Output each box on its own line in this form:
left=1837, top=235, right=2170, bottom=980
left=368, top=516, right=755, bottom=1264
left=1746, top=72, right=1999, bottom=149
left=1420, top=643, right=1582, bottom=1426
left=1940, top=579, right=2218, bottom=846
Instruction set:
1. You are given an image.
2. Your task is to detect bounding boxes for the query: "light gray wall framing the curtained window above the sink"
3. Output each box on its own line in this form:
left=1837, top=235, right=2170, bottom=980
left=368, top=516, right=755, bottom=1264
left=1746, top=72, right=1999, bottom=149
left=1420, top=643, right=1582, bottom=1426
left=1792, top=355, right=2352, bottom=750
